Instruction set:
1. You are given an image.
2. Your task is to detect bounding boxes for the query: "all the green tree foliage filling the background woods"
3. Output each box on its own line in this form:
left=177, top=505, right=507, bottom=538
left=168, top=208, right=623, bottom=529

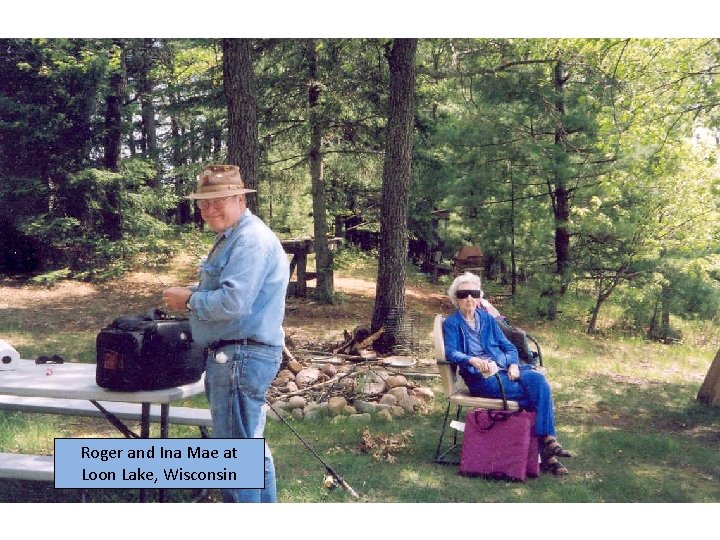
left=0, top=38, right=720, bottom=332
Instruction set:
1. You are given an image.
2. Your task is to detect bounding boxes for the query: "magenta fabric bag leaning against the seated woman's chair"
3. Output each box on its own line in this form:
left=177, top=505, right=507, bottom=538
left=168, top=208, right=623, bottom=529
left=459, top=409, right=539, bottom=481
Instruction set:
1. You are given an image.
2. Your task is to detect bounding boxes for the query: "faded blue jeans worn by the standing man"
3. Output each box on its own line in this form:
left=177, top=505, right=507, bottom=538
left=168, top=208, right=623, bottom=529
left=205, top=345, right=282, bottom=502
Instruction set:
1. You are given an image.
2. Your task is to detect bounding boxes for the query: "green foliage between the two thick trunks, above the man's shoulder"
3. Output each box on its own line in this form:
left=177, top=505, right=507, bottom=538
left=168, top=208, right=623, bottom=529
left=255, top=39, right=387, bottom=235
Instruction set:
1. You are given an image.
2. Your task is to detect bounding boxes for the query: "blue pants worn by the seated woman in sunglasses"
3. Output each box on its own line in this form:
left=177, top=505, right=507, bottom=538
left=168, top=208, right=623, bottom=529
left=465, top=365, right=555, bottom=437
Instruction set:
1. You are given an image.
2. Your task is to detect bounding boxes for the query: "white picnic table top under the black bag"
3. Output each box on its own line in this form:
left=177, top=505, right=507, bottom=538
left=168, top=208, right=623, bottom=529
left=0, top=360, right=205, bottom=403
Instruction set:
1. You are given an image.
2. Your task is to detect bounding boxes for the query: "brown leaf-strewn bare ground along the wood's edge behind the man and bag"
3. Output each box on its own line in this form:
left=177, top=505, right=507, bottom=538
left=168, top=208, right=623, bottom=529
left=0, top=260, right=451, bottom=354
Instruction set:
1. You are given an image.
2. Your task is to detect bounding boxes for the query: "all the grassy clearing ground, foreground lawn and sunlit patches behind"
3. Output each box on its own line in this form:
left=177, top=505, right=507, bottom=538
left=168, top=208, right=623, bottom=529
left=0, top=247, right=720, bottom=503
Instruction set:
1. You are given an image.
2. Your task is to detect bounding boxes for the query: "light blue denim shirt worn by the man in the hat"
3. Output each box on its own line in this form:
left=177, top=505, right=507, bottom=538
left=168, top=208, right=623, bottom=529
left=190, top=209, right=290, bottom=347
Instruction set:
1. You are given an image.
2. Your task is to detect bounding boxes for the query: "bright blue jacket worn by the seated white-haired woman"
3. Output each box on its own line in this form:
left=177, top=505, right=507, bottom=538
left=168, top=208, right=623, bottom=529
left=443, top=308, right=520, bottom=379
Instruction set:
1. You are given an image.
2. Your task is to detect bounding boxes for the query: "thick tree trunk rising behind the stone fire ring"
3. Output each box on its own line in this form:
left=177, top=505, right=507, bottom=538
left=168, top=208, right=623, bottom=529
left=371, top=39, right=417, bottom=349
